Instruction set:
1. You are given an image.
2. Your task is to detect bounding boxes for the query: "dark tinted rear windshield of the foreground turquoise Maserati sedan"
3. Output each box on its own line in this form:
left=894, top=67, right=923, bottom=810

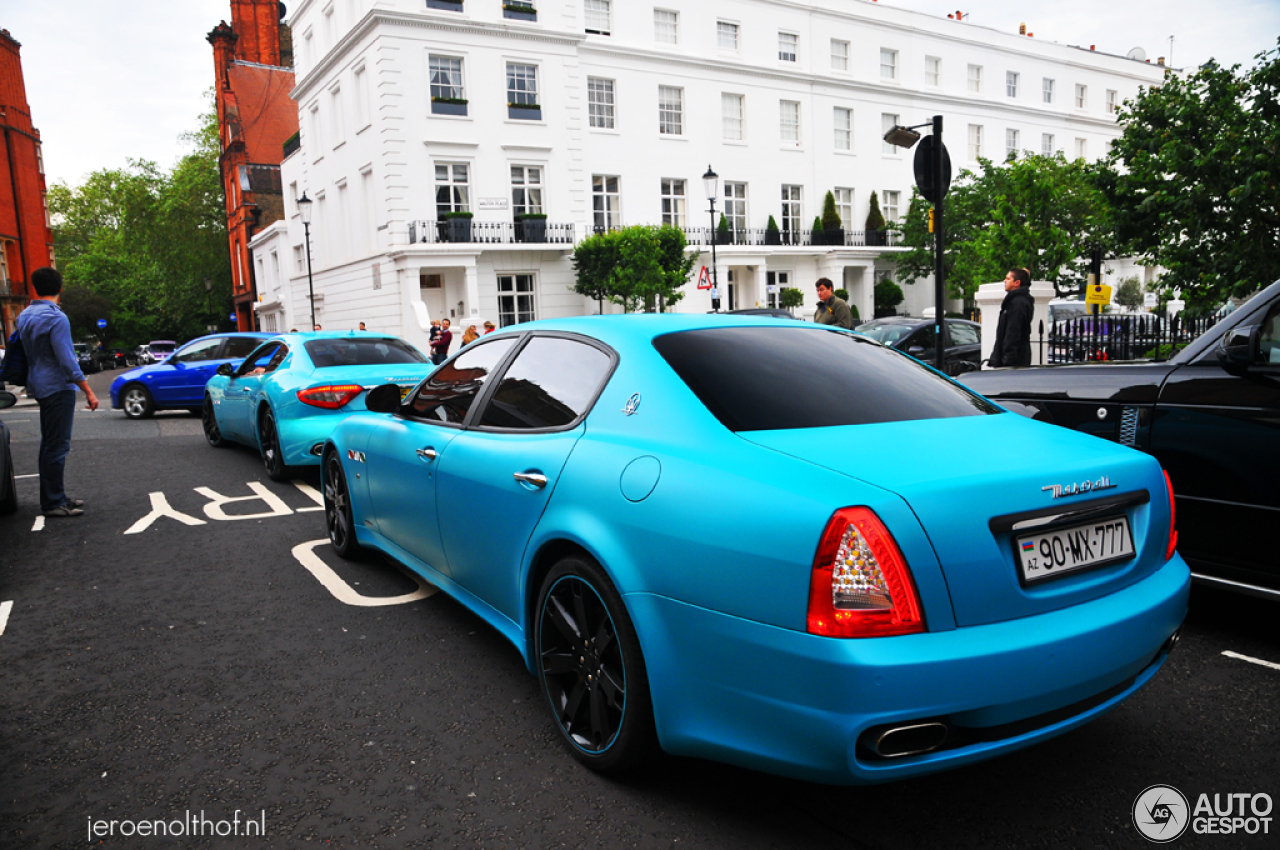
left=653, top=328, right=1002, bottom=431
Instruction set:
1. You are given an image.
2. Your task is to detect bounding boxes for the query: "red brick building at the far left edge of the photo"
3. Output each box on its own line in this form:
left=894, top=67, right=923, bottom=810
left=0, top=29, right=54, bottom=338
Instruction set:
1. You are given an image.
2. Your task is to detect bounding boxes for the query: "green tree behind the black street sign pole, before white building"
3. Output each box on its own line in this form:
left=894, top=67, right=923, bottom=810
left=897, top=154, right=1115, bottom=300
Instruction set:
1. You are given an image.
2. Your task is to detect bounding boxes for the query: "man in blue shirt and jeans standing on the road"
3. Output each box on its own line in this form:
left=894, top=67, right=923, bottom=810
left=18, top=268, right=97, bottom=516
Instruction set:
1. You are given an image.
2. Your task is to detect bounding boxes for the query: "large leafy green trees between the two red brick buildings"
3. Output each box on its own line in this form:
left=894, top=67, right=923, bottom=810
left=49, top=92, right=232, bottom=346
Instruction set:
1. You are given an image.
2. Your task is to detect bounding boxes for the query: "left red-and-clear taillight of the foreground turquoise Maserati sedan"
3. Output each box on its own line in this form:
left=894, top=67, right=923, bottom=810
left=808, top=507, right=924, bottom=638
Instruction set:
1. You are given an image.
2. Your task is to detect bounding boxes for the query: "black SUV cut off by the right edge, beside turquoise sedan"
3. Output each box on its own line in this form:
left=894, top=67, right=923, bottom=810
left=961, top=280, right=1280, bottom=599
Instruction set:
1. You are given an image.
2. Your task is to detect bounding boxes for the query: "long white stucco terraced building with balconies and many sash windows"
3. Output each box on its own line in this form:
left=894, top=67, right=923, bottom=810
left=252, top=0, right=1164, bottom=346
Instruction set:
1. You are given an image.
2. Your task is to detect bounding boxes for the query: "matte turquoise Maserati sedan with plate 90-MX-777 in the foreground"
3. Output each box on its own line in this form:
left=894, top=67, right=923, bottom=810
left=321, top=315, right=1189, bottom=783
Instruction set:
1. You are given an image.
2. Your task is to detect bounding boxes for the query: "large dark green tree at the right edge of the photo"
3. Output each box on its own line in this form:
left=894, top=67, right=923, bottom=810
left=1103, top=42, right=1280, bottom=311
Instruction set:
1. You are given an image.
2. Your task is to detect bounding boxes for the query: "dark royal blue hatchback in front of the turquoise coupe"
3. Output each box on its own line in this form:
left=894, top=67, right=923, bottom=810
left=111, top=332, right=271, bottom=419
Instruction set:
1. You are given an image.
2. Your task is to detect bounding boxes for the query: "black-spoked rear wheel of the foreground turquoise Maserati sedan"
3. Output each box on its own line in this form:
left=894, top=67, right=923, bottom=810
left=534, top=557, right=659, bottom=772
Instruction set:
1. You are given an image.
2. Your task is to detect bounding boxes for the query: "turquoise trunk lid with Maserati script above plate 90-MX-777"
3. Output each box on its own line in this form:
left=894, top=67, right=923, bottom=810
left=739, top=413, right=1169, bottom=626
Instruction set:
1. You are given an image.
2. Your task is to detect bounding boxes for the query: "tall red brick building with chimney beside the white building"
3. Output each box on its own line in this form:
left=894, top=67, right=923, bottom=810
left=209, top=0, right=298, bottom=330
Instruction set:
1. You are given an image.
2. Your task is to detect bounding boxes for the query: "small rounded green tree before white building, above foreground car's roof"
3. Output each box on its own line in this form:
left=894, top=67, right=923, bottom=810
left=573, top=225, right=698, bottom=312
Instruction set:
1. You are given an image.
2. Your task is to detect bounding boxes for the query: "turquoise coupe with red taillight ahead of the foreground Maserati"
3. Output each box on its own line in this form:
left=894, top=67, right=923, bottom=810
left=201, top=330, right=435, bottom=481
